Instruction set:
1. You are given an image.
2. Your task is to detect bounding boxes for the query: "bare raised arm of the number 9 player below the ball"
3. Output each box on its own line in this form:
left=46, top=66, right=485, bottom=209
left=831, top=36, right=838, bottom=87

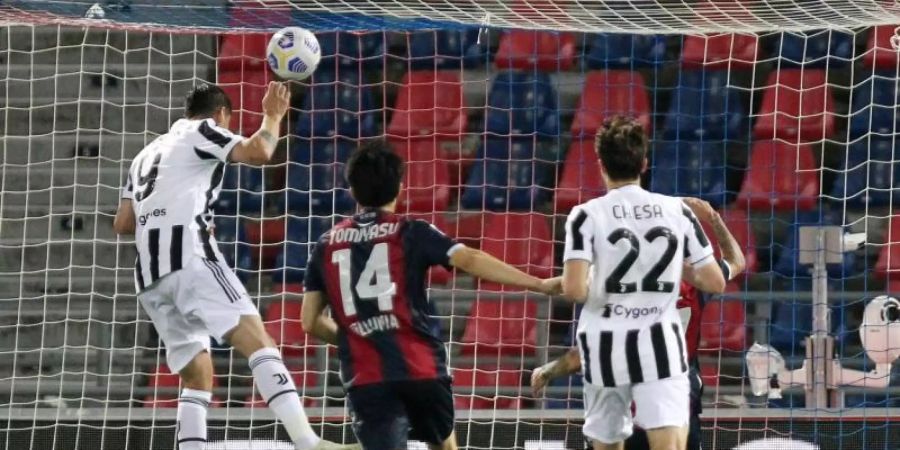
left=230, top=81, right=291, bottom=166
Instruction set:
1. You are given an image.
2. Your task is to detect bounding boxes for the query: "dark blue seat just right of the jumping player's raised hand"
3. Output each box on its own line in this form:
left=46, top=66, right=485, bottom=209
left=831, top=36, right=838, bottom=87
left=296, top=71, right=381, bottom=137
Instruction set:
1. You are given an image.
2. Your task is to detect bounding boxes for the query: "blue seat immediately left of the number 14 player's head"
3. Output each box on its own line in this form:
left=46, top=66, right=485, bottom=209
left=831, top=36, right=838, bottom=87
left=286, top=138, right=356, bottom=216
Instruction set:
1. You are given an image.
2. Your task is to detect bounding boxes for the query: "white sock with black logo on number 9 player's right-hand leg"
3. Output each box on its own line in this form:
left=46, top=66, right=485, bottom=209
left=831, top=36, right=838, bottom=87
left=250, top=347, right=320, bottom=450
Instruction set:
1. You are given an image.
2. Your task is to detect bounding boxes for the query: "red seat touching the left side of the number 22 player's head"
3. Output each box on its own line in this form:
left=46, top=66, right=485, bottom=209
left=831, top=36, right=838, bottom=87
left=553, top=138, right=606, bottom=214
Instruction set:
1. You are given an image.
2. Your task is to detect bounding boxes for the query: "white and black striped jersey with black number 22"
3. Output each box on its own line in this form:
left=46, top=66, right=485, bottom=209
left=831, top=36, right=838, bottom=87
left=563, top=185, right=715, bottom=387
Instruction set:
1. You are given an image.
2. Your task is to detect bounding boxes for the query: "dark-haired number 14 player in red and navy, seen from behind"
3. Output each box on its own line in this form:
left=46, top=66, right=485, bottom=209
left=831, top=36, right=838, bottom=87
left=302, top=140, right=561, bottom=450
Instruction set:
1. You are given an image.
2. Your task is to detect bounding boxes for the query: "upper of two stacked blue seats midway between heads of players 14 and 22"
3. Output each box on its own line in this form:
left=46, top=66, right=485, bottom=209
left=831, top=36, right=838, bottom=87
left=485, top=71, right=560, bottom=138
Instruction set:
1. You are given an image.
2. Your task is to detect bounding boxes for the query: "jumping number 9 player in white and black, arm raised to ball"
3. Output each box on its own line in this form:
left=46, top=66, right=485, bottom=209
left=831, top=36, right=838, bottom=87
left=113, top=82, right=359, bottom=450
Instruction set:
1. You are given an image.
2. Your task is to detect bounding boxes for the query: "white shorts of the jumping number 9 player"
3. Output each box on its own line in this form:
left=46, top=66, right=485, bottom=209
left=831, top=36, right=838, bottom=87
left=138, top=257, right=259, bottom=373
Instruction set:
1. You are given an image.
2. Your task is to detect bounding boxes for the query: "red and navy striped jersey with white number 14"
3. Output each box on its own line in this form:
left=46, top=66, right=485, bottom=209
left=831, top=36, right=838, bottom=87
left=305, top=210, right=462, bottom=388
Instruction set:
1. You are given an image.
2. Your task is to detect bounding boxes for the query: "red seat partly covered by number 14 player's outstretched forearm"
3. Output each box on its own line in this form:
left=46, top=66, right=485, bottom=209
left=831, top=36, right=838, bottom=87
left=480, top=213, right=553, bottom=291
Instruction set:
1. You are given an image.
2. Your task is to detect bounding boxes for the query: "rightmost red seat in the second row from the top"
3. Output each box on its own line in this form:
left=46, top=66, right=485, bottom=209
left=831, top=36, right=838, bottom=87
left=753, top=69, right=835, bottom=142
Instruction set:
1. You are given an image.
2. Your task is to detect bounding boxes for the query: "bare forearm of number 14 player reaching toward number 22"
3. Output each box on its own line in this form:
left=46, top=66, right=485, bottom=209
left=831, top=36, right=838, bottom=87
left=450, top=246, right=560, bottom=295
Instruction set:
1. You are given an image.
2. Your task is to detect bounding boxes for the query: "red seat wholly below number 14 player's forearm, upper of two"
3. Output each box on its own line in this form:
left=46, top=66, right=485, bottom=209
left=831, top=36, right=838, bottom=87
left=460, top=298, right=537, bottom=358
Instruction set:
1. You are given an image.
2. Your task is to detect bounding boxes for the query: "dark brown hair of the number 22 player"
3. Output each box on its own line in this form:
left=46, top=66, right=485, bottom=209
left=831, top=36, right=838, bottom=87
left=594, top=116, right=647, bottom=181
